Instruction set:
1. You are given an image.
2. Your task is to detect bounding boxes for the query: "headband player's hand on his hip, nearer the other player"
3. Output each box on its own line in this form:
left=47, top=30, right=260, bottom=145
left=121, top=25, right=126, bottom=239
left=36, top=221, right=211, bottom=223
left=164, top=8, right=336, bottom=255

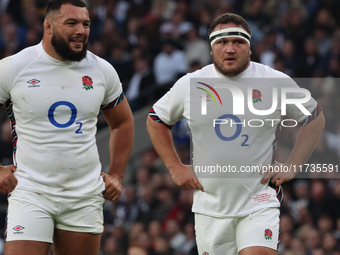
left=171, top=164, right=204, bottom=192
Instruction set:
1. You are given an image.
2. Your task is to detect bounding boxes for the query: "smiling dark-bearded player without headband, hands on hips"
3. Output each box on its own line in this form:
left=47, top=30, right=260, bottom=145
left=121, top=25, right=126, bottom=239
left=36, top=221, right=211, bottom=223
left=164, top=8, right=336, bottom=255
left=0, top=0, right=133, bottom=255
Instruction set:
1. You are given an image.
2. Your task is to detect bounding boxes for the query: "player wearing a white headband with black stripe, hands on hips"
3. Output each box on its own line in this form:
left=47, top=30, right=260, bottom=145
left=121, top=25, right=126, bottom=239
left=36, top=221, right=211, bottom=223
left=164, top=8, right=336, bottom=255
left=147, top=13, right=325, bottom=255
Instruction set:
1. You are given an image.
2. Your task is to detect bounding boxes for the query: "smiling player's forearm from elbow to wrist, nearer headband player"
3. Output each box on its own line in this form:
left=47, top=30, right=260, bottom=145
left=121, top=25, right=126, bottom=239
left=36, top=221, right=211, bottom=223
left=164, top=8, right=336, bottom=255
left=108, top=120, right=134, bottom=180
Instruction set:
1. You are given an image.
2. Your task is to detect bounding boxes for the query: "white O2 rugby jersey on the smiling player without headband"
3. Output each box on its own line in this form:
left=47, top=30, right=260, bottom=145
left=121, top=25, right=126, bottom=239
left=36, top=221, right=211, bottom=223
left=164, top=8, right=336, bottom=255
left=0, top=43, right=124, bottom=197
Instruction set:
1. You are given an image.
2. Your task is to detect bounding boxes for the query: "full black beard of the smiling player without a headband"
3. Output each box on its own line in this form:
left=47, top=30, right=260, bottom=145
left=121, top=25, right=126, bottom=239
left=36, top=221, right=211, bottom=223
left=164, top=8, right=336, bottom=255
left=51, top=28, right=88, bottom=62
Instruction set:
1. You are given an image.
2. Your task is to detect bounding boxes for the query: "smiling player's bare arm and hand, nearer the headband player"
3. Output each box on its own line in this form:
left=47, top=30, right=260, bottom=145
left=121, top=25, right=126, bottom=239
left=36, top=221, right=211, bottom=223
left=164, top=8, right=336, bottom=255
left=101, top=98, right=134, bottom=201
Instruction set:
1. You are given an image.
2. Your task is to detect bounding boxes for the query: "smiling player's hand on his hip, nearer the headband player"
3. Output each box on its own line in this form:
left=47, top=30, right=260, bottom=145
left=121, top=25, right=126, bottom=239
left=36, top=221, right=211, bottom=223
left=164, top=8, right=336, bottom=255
left=100, top=173, right=122, bottom=202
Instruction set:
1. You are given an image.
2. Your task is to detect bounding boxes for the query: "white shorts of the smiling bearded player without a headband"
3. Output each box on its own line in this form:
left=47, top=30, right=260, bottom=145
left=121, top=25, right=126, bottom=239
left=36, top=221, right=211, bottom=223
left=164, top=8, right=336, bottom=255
left=5, top=189, right=105, bottom=243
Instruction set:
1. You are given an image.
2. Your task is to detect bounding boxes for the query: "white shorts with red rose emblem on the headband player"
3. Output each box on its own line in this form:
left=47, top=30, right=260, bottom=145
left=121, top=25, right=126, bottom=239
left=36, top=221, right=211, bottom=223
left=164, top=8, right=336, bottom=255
left=195, top=208, right=280, bottom=255
